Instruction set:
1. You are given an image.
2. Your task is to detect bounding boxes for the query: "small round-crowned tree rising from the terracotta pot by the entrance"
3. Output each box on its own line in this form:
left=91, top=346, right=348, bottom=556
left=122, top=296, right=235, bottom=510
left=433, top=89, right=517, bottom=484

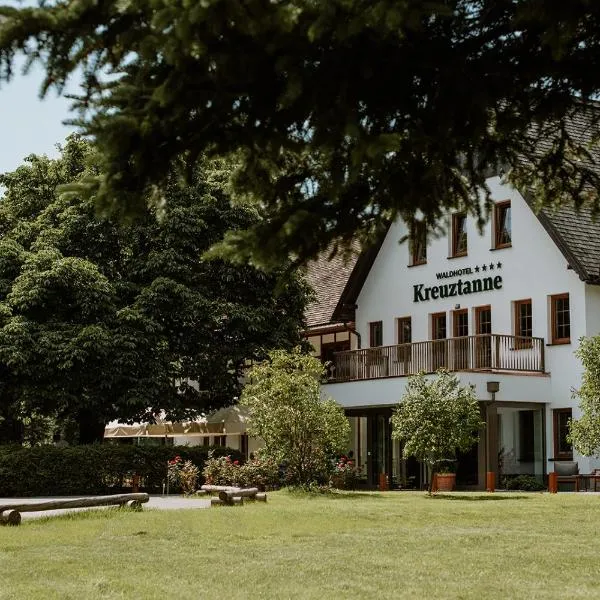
left=392, top=369, right=485, bottom=493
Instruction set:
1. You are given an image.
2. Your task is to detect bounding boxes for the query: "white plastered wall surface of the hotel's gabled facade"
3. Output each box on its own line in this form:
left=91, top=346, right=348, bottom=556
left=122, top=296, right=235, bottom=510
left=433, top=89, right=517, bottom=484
left=327, top=177, right=600, bottom=472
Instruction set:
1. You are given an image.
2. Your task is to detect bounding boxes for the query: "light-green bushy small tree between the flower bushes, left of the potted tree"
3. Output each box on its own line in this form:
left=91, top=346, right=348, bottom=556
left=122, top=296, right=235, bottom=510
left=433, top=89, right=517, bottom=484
left=240, top=349, right=350, bottom=485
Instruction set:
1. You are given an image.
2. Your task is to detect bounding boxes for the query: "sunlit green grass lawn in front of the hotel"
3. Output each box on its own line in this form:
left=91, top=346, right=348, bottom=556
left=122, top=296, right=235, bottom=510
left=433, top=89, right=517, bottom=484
left=0, top=492, right=600, bottom=600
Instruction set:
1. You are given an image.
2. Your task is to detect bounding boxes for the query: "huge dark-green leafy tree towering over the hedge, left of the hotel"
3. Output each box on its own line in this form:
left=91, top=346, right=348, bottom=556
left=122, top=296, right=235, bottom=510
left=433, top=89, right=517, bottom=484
left=0, top=137, right=307, bottom=443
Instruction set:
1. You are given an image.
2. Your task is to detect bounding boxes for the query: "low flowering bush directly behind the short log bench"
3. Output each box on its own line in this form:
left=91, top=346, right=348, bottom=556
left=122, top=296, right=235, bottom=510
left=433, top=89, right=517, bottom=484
left=202, top=454, right=279, bottom=490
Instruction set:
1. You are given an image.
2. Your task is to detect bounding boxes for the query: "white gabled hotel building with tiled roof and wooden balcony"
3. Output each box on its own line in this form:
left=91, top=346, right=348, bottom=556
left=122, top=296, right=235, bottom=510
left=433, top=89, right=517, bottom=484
left=307, top=172, right=600, bottom=488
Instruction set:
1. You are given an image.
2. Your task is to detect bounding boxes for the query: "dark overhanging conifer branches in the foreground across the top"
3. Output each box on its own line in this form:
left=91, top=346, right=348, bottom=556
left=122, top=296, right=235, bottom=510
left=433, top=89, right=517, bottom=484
left=0, top=0, right=600, bottom=263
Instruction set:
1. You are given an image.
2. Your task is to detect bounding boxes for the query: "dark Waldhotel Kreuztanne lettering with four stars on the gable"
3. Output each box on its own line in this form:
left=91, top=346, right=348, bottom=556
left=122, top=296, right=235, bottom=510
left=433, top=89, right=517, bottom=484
left=413, top=262, right=502, bottom=302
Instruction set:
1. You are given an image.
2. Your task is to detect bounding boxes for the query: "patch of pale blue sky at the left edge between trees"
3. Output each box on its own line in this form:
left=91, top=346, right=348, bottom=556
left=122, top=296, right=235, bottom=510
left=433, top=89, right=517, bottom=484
left=0, top=57, right=76, bottom=173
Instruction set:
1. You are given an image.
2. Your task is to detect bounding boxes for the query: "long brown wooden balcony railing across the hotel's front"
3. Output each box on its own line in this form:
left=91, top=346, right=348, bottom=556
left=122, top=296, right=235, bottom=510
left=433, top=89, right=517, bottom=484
left=330, top=334, right=544, bottom=382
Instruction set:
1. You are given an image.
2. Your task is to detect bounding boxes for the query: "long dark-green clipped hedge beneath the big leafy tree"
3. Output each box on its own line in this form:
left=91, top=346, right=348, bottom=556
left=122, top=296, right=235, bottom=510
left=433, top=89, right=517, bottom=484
left=0, top=444, right=242, bottom=497
